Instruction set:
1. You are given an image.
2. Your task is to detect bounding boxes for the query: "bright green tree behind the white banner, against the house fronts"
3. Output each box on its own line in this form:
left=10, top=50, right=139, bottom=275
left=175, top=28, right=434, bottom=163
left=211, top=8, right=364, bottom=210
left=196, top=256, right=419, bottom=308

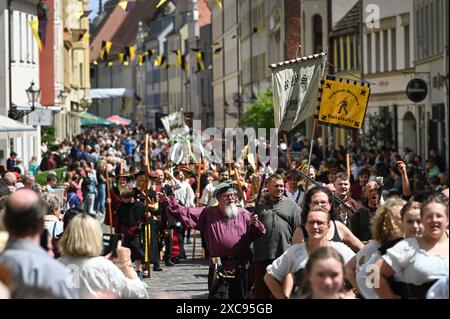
left=238, top=88, right=275, bottom=130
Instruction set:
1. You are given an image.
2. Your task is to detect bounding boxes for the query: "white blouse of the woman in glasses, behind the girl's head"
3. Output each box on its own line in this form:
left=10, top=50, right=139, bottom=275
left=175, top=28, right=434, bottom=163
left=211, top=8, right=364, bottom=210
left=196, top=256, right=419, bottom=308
left=266, top=241, right=355, bottom=281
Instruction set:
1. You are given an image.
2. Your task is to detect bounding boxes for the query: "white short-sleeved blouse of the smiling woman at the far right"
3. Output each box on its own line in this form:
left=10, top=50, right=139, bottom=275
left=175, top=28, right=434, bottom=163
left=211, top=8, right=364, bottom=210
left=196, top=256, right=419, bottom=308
left=382, top=237, right=448, bottom=285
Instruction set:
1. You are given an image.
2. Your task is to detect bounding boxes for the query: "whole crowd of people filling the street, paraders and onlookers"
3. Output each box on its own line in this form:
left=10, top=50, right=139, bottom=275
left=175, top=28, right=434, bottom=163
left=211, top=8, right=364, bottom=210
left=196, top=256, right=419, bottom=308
left=0, top=125, right=449, bottom=299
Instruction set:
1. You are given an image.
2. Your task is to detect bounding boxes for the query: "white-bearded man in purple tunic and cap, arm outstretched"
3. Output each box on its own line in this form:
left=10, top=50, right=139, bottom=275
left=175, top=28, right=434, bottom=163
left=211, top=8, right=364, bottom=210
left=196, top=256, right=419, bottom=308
left=157, top=181, right=266, bottom=299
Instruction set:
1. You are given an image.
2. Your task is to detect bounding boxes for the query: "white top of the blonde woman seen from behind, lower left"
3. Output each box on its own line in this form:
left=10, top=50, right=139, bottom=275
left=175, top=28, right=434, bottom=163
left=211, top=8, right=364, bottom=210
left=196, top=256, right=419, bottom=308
left=58, top=256, right=148, bottom=299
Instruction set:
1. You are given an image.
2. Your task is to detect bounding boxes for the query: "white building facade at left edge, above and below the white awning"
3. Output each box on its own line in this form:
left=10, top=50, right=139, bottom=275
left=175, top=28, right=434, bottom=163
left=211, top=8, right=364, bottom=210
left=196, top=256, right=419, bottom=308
left=0, top=0, right=42, bottom=166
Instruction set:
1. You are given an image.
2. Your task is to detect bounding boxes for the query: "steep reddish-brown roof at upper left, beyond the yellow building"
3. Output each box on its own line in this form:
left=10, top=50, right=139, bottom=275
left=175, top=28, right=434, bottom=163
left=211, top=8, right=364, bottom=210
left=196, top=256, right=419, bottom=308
left=90, top=0, right=158, bottom=62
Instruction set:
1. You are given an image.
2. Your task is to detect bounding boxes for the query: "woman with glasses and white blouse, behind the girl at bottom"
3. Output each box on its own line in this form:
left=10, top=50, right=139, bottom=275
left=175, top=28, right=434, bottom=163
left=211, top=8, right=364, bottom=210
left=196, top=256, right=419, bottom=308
left=264, top=206, right=355, bottom=299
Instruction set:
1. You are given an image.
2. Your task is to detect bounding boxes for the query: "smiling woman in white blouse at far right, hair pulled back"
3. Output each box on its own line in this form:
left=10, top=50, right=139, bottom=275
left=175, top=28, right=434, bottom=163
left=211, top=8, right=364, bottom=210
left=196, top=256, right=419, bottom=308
left=374, top=195, right=449, bottom=299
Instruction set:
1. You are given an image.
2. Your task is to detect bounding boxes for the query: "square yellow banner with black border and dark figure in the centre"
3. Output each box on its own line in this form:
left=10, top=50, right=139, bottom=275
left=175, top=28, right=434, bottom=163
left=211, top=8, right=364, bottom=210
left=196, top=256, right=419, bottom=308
left=319, top=80, right=370, bottom=129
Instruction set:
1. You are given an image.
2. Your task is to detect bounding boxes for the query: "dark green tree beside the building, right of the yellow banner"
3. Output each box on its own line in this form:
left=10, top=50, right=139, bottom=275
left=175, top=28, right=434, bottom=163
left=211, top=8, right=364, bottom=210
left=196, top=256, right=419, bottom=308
left=364, top=107, right=392, bottom=147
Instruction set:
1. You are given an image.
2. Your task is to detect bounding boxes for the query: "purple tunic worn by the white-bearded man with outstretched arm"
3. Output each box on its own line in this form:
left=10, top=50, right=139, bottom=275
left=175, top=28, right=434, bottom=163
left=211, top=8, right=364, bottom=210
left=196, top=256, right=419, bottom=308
left=164, top=196, right=266, bottom=268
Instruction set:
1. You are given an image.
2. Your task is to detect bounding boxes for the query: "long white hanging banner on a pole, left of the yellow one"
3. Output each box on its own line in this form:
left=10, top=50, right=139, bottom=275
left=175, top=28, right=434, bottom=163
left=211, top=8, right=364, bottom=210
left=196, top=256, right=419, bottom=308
left=272, top=53, right=325, bottom=132
